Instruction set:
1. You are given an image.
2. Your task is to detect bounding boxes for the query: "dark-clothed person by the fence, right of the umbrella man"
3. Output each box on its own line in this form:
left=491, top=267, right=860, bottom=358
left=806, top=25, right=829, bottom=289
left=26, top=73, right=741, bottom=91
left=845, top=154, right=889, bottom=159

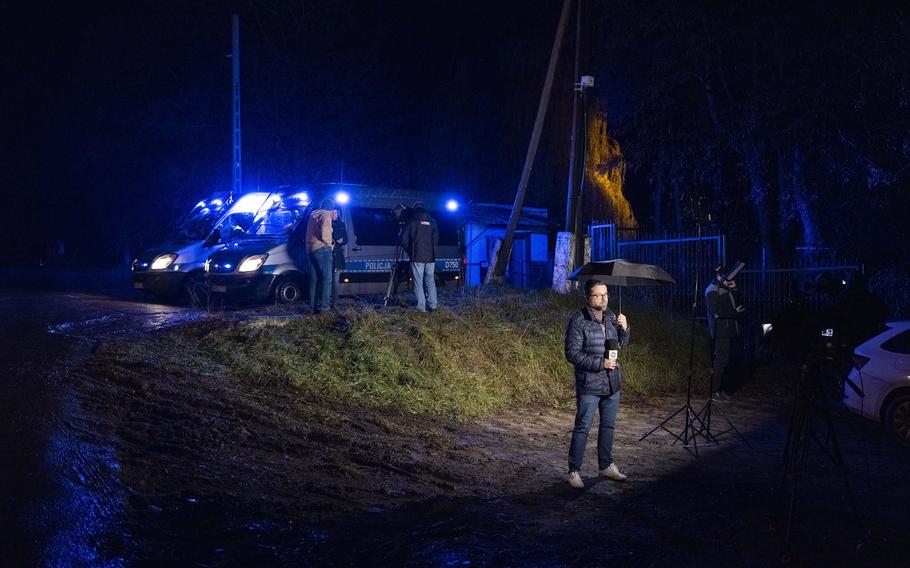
left=705, top=266, right=744, bottom=402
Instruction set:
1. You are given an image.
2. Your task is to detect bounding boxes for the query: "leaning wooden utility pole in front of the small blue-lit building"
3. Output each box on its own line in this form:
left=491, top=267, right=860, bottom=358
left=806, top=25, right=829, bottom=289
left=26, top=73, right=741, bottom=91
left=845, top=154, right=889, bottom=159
left=486, top=0, right=572, bottom=284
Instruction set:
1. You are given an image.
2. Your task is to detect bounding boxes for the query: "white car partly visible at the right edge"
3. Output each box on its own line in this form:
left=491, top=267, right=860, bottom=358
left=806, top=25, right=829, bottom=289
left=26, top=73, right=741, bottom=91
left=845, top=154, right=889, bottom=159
left=844, top=320, right=910, bottom=445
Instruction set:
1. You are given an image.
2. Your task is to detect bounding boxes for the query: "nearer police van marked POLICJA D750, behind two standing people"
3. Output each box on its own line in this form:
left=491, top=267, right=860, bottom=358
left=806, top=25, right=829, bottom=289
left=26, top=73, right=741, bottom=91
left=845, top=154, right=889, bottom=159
left=206, top=184, right=464, bottom=303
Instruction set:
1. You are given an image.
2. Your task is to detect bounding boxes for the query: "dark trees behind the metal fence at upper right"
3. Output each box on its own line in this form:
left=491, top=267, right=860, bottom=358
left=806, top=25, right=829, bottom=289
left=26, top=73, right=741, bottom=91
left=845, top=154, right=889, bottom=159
left=593, top=0, right=910, bottom=270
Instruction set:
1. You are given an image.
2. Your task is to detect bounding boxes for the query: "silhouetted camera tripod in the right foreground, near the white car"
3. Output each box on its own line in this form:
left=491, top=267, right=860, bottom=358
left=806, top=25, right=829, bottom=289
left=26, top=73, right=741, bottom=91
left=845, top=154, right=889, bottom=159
left=778, top=355, right=865, bottom=560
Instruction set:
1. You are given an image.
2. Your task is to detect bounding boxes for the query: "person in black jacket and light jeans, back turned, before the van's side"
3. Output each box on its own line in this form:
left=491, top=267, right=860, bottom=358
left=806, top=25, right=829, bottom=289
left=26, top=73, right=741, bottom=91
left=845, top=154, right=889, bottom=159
left=401, top=201, right=439, bottom=312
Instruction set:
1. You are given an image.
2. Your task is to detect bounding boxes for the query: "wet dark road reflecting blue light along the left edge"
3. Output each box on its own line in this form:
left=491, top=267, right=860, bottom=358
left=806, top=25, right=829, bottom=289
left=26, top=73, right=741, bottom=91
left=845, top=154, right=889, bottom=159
left=0, top=292, right=198, bottom=566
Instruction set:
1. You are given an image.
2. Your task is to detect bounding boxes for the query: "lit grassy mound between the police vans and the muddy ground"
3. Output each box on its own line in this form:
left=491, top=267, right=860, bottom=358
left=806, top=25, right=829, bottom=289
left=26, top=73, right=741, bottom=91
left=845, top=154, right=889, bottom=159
left=96, top=289, right=709, bottom=419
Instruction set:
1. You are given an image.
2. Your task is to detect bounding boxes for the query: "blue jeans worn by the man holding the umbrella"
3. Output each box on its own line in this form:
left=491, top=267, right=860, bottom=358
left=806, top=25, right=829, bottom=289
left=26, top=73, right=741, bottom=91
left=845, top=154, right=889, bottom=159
left=569, top=392, right=619, bottom=471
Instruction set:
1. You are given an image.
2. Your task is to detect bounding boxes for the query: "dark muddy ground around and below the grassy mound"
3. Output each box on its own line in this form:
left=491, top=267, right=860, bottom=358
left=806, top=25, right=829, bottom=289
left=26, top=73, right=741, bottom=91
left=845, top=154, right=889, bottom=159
left=4, top=290, right=910, bottom=566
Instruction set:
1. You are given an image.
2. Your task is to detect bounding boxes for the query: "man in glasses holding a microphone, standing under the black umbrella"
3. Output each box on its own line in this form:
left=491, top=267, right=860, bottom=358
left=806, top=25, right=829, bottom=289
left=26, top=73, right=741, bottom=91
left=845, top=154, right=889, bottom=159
left=565, top=279, right=630, bottom=489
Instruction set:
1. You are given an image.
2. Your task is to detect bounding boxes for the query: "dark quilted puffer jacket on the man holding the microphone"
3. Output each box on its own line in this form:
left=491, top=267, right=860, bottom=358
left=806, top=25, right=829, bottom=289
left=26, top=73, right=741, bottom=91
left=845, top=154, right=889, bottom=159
left=565, top=307, right=631, bottom=395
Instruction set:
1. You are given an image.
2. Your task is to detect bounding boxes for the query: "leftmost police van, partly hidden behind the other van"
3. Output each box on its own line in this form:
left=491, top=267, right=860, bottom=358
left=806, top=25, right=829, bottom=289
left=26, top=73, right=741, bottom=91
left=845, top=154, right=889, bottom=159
left=131, top=192, right=272, bottom=300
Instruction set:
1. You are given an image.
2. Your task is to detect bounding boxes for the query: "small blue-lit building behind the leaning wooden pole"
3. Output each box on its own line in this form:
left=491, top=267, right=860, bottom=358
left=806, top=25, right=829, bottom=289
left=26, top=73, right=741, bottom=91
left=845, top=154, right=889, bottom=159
left=464, top=203, right=555, bottom=288
